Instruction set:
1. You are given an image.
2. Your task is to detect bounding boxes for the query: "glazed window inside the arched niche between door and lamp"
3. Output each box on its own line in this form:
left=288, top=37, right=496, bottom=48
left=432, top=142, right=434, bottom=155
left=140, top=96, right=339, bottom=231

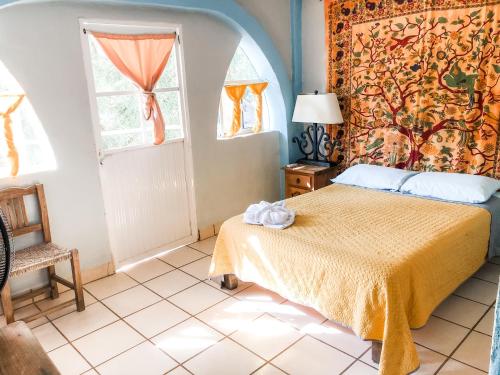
left=218, top=47, right=269, bottom=138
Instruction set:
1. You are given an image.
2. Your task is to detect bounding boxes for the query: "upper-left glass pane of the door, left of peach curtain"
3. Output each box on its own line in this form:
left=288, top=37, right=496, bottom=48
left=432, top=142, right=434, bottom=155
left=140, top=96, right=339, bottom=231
left=89, top=36, right=137, bottom=92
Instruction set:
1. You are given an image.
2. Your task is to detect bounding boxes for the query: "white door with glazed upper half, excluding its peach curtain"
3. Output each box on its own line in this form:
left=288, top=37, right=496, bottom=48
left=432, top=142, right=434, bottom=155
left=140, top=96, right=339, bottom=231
left=81, top=21, right=197, bottom=266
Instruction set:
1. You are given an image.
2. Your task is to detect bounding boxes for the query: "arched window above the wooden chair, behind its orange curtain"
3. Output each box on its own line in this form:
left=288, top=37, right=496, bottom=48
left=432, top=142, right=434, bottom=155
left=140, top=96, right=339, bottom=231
left=0, top=62, right=56, bottom=177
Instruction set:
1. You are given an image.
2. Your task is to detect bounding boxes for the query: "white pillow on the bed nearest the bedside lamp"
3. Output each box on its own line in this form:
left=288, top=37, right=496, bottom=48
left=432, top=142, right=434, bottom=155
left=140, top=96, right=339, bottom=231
left=332, top=164, right=418, bottom=191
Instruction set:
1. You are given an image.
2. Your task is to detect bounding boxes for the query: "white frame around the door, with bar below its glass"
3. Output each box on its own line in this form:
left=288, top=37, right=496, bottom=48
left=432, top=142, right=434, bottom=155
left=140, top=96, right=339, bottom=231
left=78, top=18, right=198, bottom=265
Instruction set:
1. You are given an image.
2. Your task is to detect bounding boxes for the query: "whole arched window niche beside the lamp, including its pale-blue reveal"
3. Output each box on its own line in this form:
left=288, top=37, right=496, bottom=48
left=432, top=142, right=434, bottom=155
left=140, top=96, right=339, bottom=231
left=217, top=38, right=286, bottom=139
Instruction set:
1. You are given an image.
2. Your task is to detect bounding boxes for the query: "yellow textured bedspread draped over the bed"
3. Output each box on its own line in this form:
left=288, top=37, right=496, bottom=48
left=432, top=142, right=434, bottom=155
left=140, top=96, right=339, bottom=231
left=210, top=185, right=491, bottom=375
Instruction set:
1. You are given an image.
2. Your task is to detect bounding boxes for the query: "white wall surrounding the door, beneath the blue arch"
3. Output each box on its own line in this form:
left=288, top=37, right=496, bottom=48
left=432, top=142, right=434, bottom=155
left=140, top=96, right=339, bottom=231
left=0, top=1, right=279, bottom=290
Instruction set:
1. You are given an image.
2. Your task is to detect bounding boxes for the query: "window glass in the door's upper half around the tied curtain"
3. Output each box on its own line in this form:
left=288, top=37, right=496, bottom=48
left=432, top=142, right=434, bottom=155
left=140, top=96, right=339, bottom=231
left=86, top=27, right=184, bottom=153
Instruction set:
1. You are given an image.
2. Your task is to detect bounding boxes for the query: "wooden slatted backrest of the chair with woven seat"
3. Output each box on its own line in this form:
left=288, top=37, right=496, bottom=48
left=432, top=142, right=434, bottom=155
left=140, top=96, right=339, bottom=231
left=0, top=184, right=51, bottom=242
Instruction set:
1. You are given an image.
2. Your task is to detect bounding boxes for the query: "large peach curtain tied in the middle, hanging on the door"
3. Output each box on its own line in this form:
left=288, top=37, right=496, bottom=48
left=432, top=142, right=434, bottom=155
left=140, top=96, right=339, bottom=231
left=92, top=32, right=175, bottom=145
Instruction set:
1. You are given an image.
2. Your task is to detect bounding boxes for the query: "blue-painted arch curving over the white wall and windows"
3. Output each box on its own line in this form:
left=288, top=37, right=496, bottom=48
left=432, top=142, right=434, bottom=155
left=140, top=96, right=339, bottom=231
left=0, top=0, right=293, bottom=164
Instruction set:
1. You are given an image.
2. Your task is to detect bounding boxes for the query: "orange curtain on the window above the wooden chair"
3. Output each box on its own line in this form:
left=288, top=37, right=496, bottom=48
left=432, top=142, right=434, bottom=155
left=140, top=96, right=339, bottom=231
left=0, top=94, right=24, bottom=176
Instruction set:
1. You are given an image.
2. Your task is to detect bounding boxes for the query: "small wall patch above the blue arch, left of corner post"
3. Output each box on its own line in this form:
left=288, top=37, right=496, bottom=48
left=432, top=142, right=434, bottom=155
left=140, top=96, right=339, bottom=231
left=236, top=0, right=292, bottom=78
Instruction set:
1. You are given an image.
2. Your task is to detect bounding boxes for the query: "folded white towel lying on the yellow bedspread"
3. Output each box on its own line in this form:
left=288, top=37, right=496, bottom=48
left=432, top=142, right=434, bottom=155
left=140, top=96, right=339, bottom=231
left=243, top=201, right=295, bottom=229
